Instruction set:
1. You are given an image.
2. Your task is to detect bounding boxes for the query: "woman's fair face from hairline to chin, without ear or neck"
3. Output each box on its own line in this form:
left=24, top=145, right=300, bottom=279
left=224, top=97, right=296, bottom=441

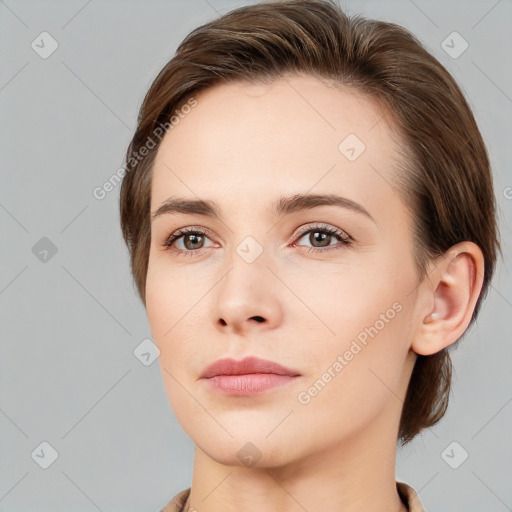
left=146, top=76, right=418, bottom=466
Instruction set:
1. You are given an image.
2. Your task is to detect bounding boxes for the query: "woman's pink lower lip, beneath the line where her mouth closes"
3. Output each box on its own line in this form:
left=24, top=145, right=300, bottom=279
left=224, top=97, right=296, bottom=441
left=205, top=373, right=299, bottom=396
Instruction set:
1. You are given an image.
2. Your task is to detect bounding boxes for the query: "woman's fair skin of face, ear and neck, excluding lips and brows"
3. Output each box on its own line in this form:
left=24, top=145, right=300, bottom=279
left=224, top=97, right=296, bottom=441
left=146, top=75, right=483, bottom=512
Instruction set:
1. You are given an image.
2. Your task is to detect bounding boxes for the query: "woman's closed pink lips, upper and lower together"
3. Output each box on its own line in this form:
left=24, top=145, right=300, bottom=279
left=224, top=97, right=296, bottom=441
left=201, top=357, right=300, bottom=396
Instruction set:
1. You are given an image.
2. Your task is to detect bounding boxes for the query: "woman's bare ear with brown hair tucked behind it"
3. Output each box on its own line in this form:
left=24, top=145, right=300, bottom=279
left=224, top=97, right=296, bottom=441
left=411, top=242, right=484, bottom=355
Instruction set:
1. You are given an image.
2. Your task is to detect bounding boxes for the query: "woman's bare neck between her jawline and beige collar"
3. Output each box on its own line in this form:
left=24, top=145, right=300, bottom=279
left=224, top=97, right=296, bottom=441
left=189, top=405, right=407, bottom=512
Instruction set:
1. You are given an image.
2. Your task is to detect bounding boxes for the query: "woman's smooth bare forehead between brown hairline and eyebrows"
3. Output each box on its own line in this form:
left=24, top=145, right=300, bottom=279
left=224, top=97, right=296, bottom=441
left=151, top=75, right=406, bottom=220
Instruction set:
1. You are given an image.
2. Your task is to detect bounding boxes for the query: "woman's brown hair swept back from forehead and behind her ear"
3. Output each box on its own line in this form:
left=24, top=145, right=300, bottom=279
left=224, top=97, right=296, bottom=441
left=119, top=0, right=501, bottom=445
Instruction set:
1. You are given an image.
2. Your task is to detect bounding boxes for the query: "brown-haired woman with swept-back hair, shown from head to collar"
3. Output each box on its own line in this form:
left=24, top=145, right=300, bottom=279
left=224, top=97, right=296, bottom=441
left=120, top=0, right=499, bottom=512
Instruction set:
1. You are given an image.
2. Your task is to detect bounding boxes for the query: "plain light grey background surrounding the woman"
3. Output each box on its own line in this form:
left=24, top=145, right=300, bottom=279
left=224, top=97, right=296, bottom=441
left=0, top=0, right=512, bottom=512
